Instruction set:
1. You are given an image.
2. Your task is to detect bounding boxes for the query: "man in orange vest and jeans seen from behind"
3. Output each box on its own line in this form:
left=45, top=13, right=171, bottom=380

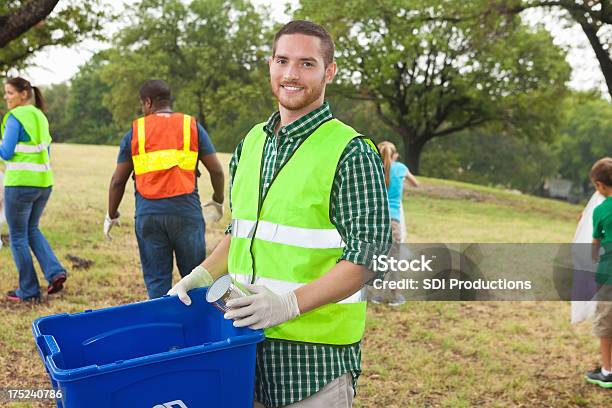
left=104, top=80, right=224, bottom=299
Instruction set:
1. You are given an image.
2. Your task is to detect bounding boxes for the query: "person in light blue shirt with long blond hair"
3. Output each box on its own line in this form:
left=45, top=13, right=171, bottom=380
left=368, top=141, right=419, bottom=306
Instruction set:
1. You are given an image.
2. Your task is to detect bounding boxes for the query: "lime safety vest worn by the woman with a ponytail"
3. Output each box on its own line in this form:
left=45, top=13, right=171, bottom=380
left=2, top=105, right=53, bottom=187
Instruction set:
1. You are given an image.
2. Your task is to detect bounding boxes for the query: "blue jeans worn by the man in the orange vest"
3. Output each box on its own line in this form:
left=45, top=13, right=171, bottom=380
left=135, top=215, right=206, bottom=299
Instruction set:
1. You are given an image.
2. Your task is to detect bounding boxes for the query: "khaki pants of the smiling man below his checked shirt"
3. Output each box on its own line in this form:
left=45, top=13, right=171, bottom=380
left=253, top=373, right=354, bottom=408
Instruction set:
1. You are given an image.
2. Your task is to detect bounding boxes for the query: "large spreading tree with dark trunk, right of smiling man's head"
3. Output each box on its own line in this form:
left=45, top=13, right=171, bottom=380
left=296, top=0, right=569, bottom=173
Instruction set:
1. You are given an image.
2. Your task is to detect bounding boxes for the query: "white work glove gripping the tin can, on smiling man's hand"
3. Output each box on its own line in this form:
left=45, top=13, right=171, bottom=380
left=223, top=285, right=300, bottom=330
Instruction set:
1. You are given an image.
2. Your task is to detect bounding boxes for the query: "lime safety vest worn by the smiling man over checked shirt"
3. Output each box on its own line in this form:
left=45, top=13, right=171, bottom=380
left=228, top=119, right=375, bottom=345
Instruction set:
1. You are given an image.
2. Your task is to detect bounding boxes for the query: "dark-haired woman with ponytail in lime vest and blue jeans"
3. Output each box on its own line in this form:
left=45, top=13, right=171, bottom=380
left=0, top=78, right=67, bottom=302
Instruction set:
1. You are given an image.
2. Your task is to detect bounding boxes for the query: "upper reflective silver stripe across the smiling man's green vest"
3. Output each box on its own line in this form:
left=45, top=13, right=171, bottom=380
left=232, top=220, right=346, bottom=249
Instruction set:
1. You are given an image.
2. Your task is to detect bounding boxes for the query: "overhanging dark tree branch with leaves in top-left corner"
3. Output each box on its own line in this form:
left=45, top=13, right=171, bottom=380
left=0, top=0, right=106, bottom=75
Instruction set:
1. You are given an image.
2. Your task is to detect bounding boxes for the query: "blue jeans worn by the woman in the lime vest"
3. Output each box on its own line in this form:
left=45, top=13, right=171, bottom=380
left=4, top=187, right=66, bottom=299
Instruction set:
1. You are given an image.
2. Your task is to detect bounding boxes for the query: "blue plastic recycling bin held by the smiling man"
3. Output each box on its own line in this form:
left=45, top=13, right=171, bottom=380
left=32, top=289, right=264, bottom=408
